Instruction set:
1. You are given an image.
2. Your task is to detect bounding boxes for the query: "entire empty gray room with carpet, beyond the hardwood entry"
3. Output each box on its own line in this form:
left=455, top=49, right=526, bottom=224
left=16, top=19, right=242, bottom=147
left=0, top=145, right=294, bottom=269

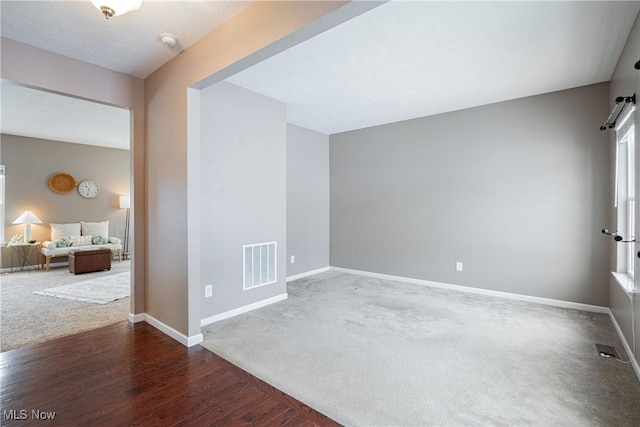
left=196, top=2, right=640, bottom=425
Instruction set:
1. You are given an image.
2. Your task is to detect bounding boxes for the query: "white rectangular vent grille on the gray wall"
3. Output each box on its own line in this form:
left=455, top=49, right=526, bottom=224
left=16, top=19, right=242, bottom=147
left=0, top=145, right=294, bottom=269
left=242, top=242, right=278, bottom=290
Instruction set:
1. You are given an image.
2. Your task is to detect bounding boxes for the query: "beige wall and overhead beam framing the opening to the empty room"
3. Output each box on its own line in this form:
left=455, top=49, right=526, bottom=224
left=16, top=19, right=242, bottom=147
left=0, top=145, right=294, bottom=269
left=144, top=1, right=380, bottom=337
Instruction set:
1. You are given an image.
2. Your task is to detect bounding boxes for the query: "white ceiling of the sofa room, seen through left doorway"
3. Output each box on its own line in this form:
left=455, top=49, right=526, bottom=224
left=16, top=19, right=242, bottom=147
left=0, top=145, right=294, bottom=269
left=0, top=81, right=131, bottom=150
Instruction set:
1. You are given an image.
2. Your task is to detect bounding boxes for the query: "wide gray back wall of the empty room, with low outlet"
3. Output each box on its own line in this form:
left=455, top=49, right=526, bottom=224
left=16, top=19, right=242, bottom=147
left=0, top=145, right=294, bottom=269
left=330, top=84, right=610, bottom=306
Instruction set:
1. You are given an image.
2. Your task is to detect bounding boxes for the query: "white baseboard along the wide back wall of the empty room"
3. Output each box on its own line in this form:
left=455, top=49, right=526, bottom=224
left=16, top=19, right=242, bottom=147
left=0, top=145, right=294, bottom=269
left=330, top=267, right=609, bottom=314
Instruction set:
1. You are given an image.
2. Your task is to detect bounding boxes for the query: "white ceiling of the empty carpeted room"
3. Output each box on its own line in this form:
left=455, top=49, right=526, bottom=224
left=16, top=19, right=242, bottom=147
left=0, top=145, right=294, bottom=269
left=228, top=1, right=640, bottom=134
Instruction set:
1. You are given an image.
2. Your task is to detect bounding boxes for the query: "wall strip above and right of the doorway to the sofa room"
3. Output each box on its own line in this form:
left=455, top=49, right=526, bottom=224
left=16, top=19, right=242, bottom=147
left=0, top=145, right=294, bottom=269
left=0, top=38, right=147, bottom=314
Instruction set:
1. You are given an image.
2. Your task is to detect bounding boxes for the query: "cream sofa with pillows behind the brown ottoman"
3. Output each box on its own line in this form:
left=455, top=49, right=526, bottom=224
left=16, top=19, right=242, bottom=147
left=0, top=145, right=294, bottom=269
left=40, top=221, right=122, bottom=271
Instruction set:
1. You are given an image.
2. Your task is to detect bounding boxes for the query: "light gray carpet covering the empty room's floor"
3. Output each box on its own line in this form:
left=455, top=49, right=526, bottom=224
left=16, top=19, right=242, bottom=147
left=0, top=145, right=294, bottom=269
left=202, top=272, right=640, bottom=426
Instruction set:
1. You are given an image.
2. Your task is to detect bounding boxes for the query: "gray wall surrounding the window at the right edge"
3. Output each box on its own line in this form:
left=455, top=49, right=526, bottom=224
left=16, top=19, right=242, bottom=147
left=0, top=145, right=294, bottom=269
left=607, top=10, right=640, bottom=363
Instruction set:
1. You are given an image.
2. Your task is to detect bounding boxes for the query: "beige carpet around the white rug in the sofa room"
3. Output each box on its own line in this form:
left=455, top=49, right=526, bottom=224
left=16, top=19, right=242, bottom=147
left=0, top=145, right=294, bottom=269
left=0, top=261, right=130, bottom=351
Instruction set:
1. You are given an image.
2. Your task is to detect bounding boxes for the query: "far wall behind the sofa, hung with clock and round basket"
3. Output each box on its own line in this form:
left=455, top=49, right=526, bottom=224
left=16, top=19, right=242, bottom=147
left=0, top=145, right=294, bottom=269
left=0, top=134, right=132, bottom=267
